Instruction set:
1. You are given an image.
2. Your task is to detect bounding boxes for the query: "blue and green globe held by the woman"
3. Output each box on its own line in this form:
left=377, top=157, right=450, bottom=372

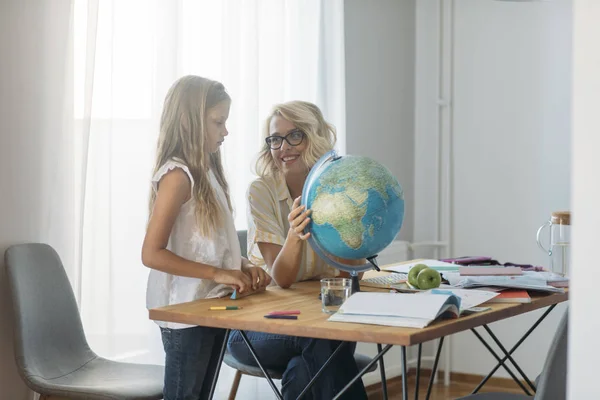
left=301, top=151, right=404, bottom=275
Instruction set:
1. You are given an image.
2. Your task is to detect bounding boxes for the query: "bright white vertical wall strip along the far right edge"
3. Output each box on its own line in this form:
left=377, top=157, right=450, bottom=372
left=568, top=0, right=600, bottom=400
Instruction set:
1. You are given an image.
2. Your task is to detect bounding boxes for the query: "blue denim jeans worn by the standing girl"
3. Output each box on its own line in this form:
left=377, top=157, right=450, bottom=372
left=160, top=326, right=225, bottom=400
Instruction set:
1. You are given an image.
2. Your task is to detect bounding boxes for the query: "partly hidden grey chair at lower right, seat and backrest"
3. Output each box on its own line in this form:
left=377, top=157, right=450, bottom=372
left=459, top=309, right=569, bottom=400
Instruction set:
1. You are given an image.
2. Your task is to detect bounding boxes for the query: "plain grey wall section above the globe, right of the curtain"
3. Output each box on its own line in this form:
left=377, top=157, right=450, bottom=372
left=344, top=0, right=415, bottom=240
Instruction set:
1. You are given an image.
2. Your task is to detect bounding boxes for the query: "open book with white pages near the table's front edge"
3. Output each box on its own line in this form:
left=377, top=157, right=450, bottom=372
left=329, top=292, right=460, bottom=328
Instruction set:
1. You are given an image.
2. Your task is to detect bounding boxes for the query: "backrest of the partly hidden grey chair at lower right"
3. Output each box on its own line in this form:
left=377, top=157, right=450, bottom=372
left=534, top=309, right=569, bottom=400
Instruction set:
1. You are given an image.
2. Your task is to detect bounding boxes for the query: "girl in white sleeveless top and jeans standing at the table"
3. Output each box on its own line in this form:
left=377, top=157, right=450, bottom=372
left=142, top=76, right=270, bottom=400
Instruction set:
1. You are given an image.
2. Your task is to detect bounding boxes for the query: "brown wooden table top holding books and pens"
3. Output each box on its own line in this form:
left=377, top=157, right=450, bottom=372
left=149, top=281, right=569, bottom=346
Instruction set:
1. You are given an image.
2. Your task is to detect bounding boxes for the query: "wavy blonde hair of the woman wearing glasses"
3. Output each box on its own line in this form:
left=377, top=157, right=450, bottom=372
left=255, top=100, right=337, bottom=178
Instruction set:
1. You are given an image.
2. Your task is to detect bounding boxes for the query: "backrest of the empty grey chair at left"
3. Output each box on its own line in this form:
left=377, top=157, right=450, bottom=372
left=4, top=243, right=96, bottom=380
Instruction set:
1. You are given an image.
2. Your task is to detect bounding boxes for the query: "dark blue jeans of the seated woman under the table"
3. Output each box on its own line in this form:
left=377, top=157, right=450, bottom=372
left=227, top=331, right=367, bottom=400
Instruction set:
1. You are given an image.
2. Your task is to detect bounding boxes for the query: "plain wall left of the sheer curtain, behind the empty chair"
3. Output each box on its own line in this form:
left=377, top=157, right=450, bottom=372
left=0, top=0, right=72, bottom=400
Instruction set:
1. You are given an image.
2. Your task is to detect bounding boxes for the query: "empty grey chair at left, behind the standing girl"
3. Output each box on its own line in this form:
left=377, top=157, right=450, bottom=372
left=4, top=243, right=164, bottom=400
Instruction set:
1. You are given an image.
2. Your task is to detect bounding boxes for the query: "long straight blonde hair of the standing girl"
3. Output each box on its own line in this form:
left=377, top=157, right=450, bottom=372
left=150, top=75, right=232, bottom=236
